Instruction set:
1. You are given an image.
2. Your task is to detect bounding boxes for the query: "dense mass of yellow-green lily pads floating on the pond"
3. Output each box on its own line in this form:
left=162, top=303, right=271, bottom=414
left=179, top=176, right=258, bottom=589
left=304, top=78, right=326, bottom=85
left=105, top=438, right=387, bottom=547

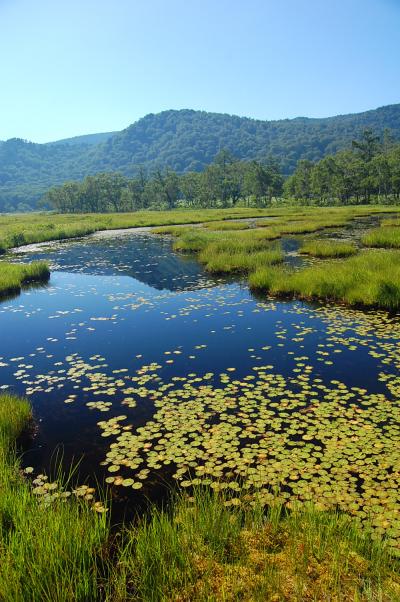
left=26, top=304, right=400, bottom=546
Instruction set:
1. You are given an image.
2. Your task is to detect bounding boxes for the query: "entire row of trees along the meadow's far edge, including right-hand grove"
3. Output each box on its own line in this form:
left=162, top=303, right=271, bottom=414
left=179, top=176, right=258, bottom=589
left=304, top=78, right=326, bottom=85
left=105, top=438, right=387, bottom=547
left=41, top=129, right=400, bottom=213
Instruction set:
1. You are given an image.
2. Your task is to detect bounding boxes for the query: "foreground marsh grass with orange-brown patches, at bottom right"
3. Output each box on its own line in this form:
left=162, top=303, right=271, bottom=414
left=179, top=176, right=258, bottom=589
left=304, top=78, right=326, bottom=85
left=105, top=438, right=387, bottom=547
left=115, top=488, right=400, bottom=602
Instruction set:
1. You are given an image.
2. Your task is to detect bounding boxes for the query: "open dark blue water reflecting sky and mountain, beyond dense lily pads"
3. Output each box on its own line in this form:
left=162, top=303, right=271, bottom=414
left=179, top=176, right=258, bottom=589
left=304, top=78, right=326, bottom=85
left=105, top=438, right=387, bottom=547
left=0, top=229, right=398, bottom=506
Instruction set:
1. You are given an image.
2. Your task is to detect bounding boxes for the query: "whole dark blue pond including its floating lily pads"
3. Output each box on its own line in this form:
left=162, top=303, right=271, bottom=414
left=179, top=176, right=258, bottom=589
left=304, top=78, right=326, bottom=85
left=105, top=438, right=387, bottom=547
left=0, top=231, right=400, bottom=539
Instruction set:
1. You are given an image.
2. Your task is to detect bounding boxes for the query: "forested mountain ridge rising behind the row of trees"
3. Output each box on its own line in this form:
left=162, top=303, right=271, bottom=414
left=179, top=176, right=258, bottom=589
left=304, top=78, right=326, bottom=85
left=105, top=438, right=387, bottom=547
left=0, top=104, right=400, bottom=211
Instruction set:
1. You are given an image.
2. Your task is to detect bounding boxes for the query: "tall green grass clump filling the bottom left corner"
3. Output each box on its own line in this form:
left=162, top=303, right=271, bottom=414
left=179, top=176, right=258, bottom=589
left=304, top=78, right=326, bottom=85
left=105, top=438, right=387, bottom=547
left=0, top=395, right=108, bottom=602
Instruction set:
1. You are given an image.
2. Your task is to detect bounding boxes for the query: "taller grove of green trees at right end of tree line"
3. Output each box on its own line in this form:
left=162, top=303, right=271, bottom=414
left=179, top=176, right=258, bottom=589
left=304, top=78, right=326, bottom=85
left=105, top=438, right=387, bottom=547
left=284, top=129, right=400, bottom=205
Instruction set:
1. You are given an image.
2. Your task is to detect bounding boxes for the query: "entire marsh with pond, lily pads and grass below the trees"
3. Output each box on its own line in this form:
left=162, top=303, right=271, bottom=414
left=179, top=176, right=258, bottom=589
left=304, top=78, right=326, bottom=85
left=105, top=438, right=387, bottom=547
left=0, top=205, right=400, bottom=602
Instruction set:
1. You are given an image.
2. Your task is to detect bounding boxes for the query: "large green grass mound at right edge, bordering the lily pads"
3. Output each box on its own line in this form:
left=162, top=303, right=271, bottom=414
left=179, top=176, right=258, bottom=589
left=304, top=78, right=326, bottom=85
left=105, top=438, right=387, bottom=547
left=249, top=251, right=400, bottom=310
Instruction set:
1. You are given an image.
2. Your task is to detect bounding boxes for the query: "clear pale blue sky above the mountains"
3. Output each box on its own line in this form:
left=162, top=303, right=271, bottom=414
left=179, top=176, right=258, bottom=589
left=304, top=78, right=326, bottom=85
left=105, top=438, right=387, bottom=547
left=0, top=0, right=400, bottom=142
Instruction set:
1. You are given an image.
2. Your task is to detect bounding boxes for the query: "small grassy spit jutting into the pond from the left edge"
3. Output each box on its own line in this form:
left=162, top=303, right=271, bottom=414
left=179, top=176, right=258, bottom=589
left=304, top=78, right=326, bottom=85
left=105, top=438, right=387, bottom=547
left=0, top=261, right=50, bottom=298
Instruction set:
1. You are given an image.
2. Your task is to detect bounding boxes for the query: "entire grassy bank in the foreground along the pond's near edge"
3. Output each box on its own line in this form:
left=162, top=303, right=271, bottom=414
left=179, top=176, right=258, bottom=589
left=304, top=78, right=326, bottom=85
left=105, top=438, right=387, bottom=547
left=0, top=395, right=400, bottom=602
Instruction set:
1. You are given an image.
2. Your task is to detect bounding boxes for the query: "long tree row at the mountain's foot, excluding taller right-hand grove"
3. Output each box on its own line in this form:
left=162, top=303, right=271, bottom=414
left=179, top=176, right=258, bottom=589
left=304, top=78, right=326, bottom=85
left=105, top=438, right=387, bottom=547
left=41, top=150, right=283, bottom=213
